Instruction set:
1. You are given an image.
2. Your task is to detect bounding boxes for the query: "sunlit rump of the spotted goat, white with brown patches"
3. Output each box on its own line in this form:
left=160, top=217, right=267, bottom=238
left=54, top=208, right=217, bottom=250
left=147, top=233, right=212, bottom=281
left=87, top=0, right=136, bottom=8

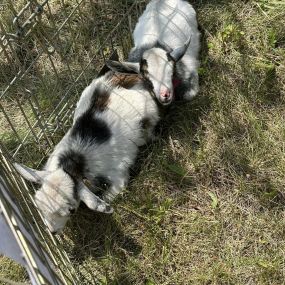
left=74, top=72, right=159, bottom=148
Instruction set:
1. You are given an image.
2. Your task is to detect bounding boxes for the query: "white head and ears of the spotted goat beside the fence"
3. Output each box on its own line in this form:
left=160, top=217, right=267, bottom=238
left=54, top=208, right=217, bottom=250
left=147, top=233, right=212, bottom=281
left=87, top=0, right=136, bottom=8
left=14, top=163, right=113, bottom=233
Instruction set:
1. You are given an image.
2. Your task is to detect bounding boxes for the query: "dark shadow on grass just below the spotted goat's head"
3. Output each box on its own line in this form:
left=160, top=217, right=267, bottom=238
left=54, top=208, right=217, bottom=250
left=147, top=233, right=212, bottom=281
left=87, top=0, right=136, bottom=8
left=64, top=205, right=141, bottom=256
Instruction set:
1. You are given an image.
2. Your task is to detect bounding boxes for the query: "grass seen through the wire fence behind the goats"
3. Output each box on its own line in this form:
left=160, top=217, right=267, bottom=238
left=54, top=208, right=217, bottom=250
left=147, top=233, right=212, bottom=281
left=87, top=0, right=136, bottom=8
left=0, top=0, right=133, bottom=160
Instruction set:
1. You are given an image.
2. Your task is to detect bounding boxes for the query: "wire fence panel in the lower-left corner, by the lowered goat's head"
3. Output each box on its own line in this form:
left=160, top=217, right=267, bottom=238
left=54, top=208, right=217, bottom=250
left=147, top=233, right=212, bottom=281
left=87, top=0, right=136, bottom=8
left=0, top=148, right=78, bottom=285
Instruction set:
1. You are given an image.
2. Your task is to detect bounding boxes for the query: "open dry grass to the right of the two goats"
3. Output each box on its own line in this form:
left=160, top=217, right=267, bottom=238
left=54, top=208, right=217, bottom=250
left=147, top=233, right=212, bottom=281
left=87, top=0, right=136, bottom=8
left=1, top=0, right=285, bottom=285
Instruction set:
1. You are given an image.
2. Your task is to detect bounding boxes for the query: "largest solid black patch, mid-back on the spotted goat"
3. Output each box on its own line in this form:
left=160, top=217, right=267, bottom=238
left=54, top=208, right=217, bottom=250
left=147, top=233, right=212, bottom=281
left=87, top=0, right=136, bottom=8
left=71, top=113, right=112, bottom=144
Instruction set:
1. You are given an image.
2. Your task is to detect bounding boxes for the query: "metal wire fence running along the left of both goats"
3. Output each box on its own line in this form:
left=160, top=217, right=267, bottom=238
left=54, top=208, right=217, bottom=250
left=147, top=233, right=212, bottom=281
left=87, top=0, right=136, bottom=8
left=0, top=0, right=147, bottom=284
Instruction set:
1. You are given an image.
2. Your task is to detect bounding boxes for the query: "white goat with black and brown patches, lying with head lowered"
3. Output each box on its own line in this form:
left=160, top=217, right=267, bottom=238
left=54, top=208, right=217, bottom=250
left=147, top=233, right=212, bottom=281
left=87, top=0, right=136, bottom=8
left=15, top=72, right=159, bottom=233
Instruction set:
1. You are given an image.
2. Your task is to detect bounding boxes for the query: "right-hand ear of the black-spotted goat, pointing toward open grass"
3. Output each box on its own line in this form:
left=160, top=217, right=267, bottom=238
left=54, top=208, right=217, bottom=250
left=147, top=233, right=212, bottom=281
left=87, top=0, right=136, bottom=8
left=79, top=183, right=114, bottom=214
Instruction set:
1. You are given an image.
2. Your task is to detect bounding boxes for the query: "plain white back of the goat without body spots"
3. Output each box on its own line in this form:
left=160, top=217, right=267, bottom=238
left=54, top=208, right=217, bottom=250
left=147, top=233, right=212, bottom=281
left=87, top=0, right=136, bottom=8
left=133, top=0, right=199, bottom=56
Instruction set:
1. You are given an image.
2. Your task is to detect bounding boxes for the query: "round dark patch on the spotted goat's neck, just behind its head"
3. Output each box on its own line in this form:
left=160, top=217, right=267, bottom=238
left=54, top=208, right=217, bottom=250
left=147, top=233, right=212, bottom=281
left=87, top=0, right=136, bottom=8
left=58, top=150, right=86, bottom=179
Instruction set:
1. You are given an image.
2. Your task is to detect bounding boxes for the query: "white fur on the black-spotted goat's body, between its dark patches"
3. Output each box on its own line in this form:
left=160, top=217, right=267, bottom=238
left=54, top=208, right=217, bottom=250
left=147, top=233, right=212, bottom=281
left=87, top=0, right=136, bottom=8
left=69, top=74, right=159, bottom=200
